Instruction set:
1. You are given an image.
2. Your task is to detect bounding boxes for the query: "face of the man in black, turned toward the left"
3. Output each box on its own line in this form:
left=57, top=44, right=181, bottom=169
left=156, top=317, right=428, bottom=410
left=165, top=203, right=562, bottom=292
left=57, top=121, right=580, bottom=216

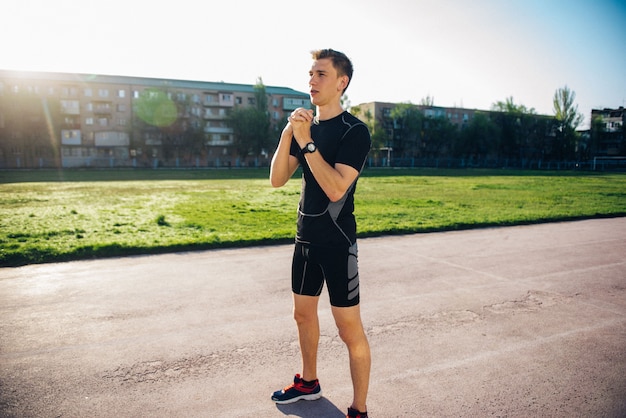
left=309, top=58, right=348, bottom=106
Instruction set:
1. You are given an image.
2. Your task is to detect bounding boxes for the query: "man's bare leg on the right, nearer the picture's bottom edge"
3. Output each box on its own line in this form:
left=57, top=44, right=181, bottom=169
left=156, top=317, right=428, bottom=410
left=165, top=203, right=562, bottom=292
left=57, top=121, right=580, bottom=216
left=332, top=305, right=372, bottom=412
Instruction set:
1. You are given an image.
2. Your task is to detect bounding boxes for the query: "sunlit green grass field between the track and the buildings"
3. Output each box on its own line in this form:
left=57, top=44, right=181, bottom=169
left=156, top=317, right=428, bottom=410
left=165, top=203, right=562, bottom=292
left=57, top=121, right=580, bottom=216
left=0, top=169, right=626, bottom=266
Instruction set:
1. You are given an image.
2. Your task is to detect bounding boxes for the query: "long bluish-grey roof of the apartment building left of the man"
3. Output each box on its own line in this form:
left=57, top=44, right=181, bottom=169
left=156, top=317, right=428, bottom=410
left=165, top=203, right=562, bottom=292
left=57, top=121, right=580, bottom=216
left=0, top=69, right=309, bottom=97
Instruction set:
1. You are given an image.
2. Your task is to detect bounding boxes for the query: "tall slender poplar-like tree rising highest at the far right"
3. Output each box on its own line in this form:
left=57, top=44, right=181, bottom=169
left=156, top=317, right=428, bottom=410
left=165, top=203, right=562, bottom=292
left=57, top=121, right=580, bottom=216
left=552, top=86, right=583, bottom=158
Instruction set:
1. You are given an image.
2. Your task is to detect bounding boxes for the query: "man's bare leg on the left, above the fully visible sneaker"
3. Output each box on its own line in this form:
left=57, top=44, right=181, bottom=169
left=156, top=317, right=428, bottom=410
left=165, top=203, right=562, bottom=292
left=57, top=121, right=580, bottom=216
left=293, top=294, right=320, bottom=381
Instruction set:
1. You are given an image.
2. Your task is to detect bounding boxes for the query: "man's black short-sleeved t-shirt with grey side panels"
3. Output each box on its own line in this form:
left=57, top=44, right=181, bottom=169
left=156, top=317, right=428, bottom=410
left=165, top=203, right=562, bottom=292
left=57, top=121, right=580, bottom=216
left=290, top=112, right=371, bottom=247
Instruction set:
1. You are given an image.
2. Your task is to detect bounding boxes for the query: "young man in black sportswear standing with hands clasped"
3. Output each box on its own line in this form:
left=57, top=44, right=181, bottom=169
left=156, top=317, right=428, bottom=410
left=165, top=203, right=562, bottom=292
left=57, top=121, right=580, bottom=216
left=270, top=49, right=371, bottom=418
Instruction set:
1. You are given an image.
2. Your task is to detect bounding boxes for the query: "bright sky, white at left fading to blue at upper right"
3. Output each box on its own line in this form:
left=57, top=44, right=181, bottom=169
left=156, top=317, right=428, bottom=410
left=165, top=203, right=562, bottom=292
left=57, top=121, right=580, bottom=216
left=0, top=0, right=626, bottom=127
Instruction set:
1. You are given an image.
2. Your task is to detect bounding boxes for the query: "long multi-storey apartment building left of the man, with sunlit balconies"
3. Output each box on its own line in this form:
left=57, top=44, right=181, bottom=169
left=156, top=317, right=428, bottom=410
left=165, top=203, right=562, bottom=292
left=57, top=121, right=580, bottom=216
left=0, top=70, right=310, bottom=168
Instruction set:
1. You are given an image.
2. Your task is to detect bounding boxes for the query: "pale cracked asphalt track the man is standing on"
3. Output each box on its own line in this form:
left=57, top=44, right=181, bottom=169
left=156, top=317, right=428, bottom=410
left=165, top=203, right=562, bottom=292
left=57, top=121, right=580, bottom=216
left=0, top=218, right=626, bottom=418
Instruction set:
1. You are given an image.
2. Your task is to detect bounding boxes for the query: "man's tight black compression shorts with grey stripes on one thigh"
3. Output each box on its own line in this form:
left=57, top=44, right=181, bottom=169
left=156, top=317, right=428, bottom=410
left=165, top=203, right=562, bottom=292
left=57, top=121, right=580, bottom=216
left=291, top=243, right=360, bottom=307
